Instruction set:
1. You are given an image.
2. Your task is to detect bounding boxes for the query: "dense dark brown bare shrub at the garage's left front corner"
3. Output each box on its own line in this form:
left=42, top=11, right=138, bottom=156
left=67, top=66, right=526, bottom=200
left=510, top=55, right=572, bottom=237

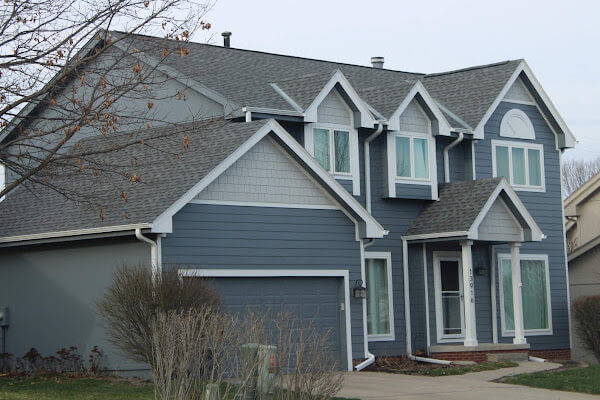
left=97, top=265, right=220, bottom=366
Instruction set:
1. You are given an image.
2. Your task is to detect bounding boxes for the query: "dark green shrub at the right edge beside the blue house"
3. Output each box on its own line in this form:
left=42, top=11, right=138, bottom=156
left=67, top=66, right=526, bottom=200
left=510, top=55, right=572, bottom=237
left=571, top=296, right=600, bottom=361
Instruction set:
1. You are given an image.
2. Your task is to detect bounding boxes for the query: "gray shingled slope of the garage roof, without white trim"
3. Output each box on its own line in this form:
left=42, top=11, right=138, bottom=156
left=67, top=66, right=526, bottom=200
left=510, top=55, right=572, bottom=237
left=0, top=120, right=268, bottom=237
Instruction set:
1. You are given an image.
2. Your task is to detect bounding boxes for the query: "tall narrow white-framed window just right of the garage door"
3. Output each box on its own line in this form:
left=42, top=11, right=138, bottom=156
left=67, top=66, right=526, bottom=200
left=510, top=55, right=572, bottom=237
left=365, top=252, right=394, bottom=341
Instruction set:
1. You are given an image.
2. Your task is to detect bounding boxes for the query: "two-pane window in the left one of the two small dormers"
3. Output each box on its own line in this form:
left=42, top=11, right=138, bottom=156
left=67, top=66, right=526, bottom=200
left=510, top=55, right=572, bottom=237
left=313, top=128, right=350, bottom=175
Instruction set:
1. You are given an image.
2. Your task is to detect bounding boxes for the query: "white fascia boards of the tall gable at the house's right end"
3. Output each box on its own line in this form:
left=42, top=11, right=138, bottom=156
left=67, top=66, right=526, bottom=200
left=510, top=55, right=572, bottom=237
left=474, top=60, right=577, bottom=148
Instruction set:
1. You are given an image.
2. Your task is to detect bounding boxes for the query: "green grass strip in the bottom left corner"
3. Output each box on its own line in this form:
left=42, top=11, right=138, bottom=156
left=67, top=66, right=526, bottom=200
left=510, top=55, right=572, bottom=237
left=0, top=377, right=357, bottom=400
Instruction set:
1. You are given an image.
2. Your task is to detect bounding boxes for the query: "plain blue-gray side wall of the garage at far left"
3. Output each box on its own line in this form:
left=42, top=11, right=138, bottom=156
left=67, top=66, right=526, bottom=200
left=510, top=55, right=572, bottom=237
left=0, top=237, right=150, bottom=370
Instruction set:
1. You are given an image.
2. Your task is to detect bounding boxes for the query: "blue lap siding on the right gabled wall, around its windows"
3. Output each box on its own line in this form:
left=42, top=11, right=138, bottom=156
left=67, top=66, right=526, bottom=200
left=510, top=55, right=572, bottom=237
left=475, top=102, right=569, bottom=350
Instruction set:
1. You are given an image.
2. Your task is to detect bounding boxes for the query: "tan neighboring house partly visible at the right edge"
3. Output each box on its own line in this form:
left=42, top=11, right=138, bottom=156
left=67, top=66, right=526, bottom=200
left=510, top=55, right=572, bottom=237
left=564, top=173, right=600, bottom=362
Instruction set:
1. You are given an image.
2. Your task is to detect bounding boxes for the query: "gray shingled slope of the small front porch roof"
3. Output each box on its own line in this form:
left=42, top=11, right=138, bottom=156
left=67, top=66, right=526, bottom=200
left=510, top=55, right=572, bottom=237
left=405, top=178, right=503, bottom=236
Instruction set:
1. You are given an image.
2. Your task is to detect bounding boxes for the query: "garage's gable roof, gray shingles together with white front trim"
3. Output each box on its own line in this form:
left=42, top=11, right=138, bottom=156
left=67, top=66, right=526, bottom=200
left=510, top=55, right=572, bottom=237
left=0, top=120, right=385, bottom=243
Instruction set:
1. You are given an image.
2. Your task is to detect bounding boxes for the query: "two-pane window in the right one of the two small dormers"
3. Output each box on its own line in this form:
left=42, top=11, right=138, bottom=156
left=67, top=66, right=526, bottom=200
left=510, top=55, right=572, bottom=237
left=395, top=135, right=429, bottom=180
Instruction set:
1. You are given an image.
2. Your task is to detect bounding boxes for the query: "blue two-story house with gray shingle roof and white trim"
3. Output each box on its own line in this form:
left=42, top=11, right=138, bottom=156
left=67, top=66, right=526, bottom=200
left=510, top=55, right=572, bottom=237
left=0, top=32, right=575, bottom=370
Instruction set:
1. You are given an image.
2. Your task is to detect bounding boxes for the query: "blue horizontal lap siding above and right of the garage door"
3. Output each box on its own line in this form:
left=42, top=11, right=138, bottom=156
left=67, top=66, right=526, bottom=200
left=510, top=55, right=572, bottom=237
left=161, top=204, right=364, bottom=358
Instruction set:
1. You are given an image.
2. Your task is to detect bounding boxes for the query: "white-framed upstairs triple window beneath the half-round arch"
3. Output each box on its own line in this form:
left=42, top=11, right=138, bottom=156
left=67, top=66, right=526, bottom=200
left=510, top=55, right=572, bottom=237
left=492, top=140, right=545, bottom=191
